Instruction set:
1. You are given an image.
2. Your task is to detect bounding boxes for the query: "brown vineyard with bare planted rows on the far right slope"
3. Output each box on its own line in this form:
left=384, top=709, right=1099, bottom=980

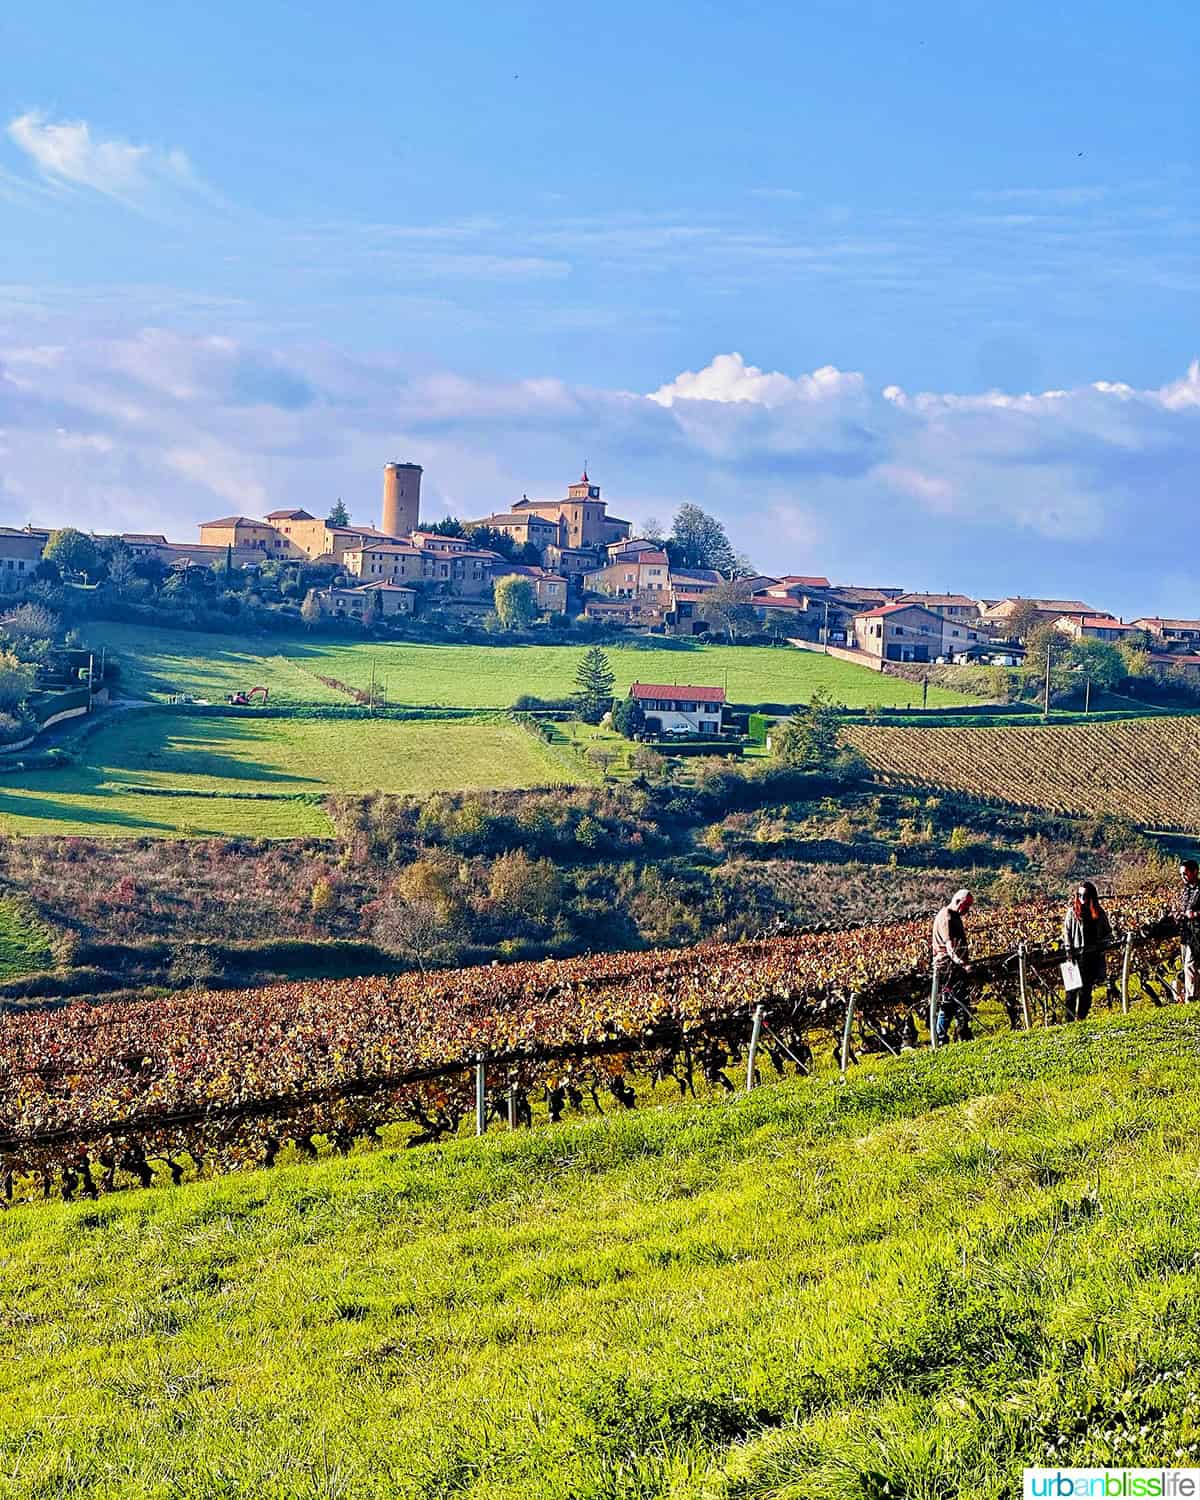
left=845, top=717, right=1200, bottom=830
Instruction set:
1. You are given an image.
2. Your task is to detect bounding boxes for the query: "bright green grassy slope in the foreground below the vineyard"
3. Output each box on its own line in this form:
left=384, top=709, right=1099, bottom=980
left=0, top=1010, right=1200, bottom=1500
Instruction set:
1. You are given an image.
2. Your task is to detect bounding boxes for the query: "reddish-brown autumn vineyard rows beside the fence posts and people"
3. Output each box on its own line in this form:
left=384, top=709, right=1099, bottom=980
left=0, top=896, right=1170, bottom=1200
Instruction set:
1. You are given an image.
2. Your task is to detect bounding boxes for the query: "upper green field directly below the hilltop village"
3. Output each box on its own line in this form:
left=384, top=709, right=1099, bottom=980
left=90, top=623, right=974, bottom=708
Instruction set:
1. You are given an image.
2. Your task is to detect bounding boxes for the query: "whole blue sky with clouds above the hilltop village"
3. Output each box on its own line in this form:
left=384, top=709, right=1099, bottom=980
left=0, top=0, right=1200, bottom=614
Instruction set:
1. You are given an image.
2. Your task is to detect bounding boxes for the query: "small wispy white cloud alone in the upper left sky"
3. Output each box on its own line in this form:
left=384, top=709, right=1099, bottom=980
left=6, top=110, right=197, bottom=207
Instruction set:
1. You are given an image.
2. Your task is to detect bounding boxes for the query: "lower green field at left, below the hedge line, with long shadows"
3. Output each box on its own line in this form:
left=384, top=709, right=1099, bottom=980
left=0, top=708, right=576, bottom=839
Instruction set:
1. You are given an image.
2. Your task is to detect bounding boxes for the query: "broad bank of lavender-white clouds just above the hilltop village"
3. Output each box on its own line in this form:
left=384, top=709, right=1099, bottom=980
left=0, top=327, right=1200, bottom=617
